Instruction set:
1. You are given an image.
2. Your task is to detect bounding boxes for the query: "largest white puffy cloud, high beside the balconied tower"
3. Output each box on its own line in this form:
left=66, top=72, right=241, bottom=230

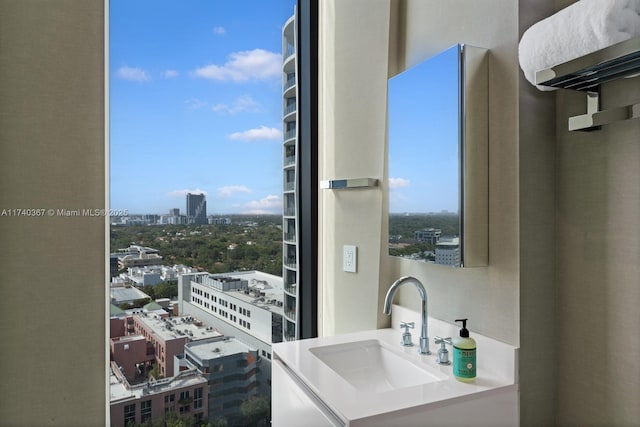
left=193, top=49, right=282, bottom=82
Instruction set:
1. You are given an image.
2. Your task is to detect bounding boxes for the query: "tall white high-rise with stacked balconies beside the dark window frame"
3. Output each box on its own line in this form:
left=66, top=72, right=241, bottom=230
left=282, top=12, right=299, bottom=341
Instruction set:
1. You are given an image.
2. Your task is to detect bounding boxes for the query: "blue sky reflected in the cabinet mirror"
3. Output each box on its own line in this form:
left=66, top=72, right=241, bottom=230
left=389, top=47, right=459, bottom=213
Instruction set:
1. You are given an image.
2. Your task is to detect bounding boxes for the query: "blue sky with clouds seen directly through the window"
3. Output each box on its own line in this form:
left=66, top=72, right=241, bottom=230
left=109, top=0, right=295, bottom=214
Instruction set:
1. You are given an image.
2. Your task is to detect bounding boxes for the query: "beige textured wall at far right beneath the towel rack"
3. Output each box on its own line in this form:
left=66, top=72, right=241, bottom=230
left=556, top=1, right=640, bottom=426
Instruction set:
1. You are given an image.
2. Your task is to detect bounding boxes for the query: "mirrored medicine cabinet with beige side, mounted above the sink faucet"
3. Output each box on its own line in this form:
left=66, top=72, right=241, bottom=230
left=388, top=44, right=489, bottom=267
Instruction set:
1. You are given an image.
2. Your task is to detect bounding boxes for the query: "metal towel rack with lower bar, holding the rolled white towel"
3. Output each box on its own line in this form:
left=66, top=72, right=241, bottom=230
left=536, top=37, right=640, bottom=131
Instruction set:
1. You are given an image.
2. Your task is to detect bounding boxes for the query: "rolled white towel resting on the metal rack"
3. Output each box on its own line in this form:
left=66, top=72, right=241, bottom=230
left=519, top=0, right=640, bottom=90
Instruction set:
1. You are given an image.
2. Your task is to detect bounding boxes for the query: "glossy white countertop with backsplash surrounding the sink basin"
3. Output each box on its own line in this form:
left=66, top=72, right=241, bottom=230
left=273, top=306, right=517, bottom=421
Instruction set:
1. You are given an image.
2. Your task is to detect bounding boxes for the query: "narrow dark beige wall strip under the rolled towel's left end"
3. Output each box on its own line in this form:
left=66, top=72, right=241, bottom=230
left=518, top=0, right=557, bottom=426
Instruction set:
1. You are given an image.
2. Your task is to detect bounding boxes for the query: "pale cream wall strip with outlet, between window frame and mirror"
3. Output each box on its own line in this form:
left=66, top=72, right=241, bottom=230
left=318, top=0, right=390, bottom=335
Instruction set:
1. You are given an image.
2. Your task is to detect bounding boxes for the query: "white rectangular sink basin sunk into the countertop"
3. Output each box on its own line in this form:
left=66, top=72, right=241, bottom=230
left=309, top=339, right=447, bottom=393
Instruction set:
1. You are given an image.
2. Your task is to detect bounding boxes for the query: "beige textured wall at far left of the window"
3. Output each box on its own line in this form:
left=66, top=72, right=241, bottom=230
left=0, top=0, right=108, bottom=427
